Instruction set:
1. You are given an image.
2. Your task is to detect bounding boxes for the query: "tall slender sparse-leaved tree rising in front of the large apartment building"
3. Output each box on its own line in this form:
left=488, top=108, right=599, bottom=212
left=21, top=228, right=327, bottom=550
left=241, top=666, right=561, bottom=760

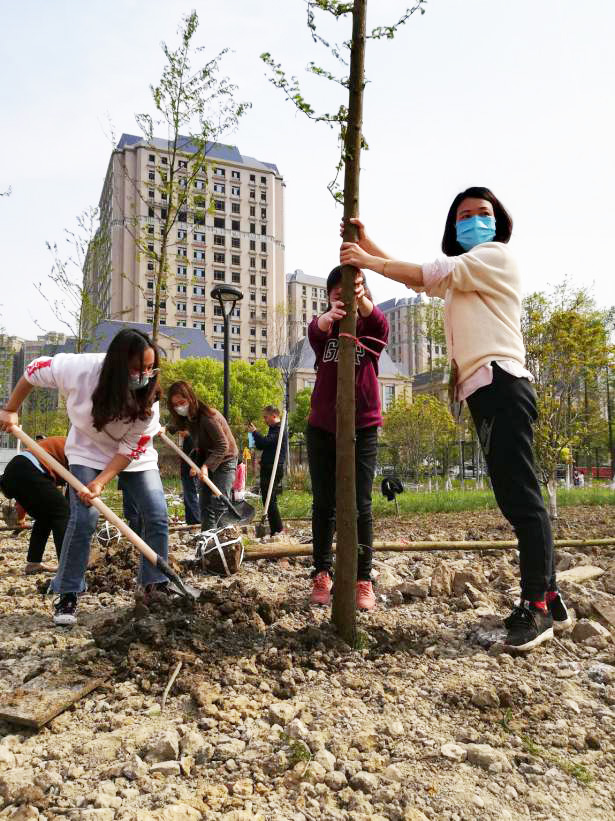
left=118, top=11, right=250, bottom=341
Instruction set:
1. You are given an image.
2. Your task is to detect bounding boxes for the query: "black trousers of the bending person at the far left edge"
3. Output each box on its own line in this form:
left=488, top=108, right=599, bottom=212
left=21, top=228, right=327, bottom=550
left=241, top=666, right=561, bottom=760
left=2, top=455, right=70, bottom=563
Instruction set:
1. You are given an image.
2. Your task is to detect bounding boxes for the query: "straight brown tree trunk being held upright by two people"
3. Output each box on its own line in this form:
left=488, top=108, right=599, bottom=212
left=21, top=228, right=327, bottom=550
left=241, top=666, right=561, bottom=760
left=331, top=0, right=367, bottom=646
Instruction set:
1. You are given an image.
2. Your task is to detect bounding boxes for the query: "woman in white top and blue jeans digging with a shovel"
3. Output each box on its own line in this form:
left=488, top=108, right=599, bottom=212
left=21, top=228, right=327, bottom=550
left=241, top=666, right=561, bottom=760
left=0, top=329, right=168, bottom=625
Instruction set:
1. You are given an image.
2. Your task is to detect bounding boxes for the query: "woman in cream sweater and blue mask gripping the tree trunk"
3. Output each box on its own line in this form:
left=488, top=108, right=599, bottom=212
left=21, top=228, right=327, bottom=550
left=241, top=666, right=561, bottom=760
left=340, top=187, right=570, bottom=650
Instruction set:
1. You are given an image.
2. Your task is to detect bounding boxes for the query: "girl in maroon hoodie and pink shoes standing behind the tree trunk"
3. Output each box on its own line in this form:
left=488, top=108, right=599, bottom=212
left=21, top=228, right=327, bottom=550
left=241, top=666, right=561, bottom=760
left=306, top=266, right=389, bottom=610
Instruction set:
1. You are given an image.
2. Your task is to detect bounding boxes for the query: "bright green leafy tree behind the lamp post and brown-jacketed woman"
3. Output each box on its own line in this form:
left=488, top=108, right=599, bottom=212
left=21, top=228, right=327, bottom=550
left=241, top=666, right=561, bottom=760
left=162, top=358, right=282, bottom=444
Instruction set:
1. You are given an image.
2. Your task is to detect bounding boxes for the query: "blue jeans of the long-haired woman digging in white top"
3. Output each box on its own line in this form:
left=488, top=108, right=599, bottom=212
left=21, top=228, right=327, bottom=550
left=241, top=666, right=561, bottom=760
left=49, top=465, right=169, bottom=593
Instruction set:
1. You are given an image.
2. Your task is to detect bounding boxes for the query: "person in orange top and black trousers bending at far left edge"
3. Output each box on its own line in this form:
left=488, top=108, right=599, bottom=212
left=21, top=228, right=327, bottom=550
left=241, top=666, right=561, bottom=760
left=0, top=436, right=70, bottom=575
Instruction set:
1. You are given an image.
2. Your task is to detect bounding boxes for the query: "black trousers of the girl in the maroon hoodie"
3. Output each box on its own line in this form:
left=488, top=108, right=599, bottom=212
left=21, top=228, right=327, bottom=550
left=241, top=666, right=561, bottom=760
left=306, top=425, right=378, bottom=581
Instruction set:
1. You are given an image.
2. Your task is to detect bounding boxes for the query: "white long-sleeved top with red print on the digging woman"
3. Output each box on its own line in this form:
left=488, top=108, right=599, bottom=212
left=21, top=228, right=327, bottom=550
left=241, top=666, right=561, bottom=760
left=24, top=353, right=160, bottom=471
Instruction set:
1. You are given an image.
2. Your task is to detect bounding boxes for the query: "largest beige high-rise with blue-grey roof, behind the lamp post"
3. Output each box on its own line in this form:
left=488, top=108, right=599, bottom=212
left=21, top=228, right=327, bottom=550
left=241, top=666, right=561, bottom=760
left=85, top=134, right=286, bottom=362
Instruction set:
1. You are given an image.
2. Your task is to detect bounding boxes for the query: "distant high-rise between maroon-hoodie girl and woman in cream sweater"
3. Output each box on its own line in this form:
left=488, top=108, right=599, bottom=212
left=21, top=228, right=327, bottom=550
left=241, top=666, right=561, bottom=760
left=378, top=294, right=446, bottom=376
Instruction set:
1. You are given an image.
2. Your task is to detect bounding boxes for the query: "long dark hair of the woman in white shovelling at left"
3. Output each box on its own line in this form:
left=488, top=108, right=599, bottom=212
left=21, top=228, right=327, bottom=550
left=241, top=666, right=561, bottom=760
left=92, top=328, right=160, bottom=430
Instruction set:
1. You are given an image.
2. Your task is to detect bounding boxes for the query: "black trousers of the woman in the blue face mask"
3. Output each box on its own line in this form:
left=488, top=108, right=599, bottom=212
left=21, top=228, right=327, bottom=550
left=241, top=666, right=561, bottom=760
left=467, top=362, right=556, bottom=601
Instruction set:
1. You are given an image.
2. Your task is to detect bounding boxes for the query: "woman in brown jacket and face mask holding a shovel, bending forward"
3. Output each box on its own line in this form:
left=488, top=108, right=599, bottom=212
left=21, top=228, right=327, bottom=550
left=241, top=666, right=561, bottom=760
left=167, top=382, right=238, bottom=530
